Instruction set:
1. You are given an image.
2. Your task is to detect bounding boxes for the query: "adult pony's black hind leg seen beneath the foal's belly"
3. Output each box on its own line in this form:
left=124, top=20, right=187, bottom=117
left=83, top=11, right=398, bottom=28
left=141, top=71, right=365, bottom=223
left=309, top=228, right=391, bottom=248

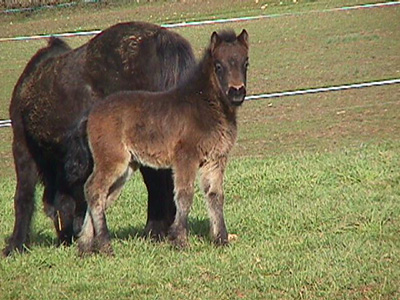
left=140, top=167, right=176, bottom=240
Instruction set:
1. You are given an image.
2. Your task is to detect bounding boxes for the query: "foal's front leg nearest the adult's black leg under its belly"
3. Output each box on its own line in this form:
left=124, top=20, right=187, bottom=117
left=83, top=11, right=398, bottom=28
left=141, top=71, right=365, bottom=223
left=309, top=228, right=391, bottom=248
left=168, top=162, right=197, bottom=248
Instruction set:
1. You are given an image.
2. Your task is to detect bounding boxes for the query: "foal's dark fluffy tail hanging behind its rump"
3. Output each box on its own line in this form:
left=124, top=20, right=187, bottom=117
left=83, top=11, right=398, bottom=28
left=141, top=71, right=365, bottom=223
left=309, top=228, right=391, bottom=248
left=64, top=116, right=93, bottom=187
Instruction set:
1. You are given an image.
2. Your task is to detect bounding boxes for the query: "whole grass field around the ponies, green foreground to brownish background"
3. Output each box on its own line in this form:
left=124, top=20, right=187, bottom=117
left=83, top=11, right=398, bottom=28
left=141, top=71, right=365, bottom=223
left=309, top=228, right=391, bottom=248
left=0, top=0, right=400, bottom=299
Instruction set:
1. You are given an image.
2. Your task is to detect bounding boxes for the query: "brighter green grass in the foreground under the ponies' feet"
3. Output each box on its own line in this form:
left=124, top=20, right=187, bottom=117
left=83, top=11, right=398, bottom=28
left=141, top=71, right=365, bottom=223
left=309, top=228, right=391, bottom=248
left=0, top=142, right=400, bottom=299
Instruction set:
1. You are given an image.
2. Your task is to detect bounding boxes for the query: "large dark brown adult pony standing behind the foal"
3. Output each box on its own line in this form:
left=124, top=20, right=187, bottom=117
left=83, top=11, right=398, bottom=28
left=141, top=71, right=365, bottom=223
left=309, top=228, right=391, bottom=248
left=3, top=22, right=194, bottom=255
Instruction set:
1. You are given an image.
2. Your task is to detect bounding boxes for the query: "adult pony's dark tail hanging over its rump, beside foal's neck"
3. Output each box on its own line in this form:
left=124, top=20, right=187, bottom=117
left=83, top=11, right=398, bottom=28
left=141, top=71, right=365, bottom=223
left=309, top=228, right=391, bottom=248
left=155, top=29, right=196, bottom=90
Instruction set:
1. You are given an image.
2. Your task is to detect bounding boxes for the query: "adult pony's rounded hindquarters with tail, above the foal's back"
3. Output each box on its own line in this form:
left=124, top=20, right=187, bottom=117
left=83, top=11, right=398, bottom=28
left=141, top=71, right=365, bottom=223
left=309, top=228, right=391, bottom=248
left=85, top=22, right=195, bottom=96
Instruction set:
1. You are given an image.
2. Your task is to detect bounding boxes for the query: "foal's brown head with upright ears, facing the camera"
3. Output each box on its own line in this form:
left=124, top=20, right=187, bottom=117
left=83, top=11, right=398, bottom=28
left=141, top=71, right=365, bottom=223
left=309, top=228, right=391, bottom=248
left=210, top=29, right=249, bottom=106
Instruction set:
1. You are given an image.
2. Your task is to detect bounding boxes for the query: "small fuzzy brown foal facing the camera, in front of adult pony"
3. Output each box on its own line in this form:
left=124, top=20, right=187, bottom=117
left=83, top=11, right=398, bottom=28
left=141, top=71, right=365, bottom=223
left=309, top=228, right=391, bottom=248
left=78, top=30, right=249, bottom=254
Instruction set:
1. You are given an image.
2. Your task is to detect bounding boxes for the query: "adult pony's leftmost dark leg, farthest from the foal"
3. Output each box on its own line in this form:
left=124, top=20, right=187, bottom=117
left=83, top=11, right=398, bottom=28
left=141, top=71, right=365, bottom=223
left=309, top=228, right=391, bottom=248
left=3, top=120, right=38, bottom=256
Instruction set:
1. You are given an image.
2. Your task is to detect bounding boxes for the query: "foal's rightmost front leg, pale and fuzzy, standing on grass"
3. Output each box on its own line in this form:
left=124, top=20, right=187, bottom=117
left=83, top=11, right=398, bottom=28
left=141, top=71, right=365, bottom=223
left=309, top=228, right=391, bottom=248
left=200, top=158, right=228, bottom=245
